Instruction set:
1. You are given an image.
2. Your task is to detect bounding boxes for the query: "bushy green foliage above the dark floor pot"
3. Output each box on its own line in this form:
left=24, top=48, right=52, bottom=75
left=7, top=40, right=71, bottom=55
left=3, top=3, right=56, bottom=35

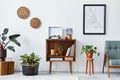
left=20, top=52, right=41, bottom=66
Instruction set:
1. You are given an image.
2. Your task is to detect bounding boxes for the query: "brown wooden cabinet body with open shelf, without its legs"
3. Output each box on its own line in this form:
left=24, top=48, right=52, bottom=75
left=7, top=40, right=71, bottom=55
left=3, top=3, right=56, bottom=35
left=46, top=39, right=76, bottom=62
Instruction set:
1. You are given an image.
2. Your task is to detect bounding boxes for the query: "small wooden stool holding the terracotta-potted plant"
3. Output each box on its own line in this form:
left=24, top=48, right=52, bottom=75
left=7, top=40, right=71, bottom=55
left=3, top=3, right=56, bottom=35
left=86, top=58, right=94, bottom=75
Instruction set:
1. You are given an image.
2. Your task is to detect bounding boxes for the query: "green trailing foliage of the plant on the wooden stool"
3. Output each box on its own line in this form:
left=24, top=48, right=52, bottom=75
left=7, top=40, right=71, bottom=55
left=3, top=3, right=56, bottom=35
left=80, top=45, right=100, bottom=56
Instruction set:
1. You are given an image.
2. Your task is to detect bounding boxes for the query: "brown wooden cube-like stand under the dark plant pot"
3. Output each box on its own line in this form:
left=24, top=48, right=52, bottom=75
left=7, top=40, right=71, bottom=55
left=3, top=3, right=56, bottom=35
left=0, top=61, right=14, bottom=75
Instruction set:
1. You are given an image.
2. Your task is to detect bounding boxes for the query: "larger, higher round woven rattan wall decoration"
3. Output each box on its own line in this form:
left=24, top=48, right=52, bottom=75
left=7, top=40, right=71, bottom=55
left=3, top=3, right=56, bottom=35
left=17, top=6, right=30, bottom=19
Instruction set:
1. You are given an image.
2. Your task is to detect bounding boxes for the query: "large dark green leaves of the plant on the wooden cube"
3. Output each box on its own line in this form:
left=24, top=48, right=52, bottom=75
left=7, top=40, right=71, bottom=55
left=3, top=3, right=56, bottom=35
left=0, top=28, right=21, bottom=52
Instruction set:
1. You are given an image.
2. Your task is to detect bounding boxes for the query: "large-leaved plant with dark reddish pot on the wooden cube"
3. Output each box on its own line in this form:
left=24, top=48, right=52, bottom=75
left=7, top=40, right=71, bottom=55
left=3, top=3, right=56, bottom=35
left=0, top=28, right=21, bottom=61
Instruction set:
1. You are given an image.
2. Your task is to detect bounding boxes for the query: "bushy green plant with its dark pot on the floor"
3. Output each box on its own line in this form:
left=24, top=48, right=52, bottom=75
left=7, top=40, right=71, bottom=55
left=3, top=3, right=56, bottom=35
left=20, top=52, right=40, bottom=75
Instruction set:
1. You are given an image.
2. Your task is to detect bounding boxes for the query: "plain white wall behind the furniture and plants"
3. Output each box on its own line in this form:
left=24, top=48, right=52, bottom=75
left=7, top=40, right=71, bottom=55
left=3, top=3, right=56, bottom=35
left=0, top=0, right=120, bottom=72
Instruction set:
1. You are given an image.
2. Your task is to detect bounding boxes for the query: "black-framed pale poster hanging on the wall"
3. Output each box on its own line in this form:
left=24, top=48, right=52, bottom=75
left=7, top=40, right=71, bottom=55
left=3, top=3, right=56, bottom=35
left=83, top=4, right=106, bottom=35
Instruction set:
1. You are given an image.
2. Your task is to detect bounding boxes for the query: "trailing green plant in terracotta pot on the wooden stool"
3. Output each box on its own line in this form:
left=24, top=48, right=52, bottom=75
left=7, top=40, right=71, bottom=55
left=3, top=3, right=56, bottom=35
left=80, top=45, right=100, bottom=58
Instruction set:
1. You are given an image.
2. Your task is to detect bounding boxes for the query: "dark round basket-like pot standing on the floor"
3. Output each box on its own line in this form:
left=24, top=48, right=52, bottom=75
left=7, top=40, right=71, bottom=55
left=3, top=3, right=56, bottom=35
left=22, top=64, right=39, bottom=76
